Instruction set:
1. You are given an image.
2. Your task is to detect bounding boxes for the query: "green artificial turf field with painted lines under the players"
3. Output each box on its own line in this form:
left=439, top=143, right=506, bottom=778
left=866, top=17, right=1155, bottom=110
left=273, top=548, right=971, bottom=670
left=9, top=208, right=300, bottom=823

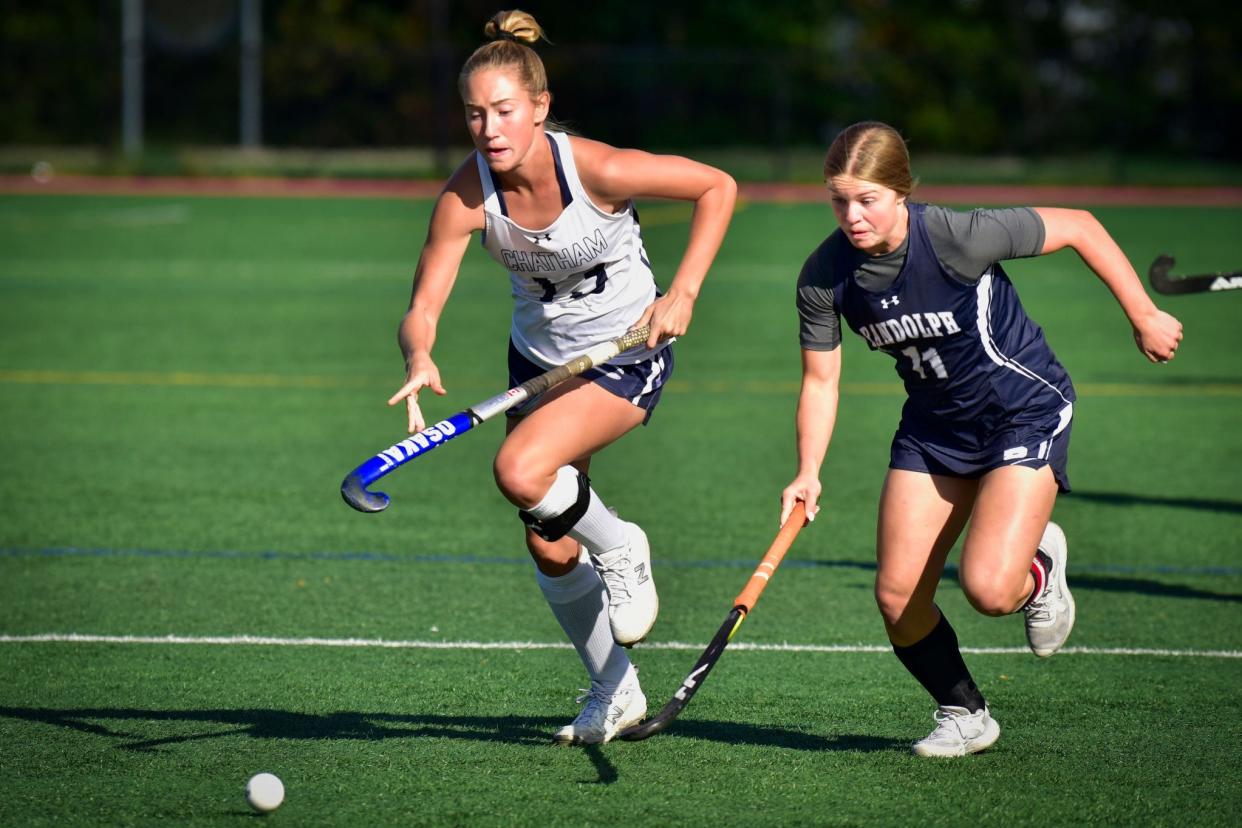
left=0, top=196, right=1242, bottom=826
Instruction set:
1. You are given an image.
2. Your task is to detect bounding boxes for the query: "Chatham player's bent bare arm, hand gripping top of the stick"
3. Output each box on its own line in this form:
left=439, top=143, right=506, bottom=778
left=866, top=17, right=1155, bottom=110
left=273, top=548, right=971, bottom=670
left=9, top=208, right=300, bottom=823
left=574, top=139, right=738, bottom=348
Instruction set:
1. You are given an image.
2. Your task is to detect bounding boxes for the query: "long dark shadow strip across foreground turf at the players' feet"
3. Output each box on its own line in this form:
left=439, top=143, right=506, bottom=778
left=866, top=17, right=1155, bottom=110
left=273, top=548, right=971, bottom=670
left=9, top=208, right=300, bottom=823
left=0, top=708, right=905, bottom=759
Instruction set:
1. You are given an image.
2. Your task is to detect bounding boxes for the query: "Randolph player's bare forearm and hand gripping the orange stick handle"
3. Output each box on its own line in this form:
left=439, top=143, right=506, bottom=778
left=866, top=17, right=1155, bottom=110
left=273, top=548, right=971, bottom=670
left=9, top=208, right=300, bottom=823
left=780, top=348, right=841, bottom=525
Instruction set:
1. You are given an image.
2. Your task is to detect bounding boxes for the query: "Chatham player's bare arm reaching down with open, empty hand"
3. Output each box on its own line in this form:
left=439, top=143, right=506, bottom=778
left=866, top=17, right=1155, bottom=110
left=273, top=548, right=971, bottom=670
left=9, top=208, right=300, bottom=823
left=389, top=172, right=483, bottom=433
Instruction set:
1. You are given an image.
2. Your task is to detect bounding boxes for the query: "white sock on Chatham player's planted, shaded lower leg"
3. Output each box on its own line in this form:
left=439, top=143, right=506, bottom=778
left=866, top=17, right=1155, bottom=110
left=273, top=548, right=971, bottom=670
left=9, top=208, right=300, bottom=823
left=535, top=546, right=635, bottom=690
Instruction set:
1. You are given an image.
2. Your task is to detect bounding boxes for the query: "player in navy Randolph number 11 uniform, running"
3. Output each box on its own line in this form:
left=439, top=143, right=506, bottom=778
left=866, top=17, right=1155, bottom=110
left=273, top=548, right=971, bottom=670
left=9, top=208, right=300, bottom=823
left=781, top=122, right=1181, bottom=756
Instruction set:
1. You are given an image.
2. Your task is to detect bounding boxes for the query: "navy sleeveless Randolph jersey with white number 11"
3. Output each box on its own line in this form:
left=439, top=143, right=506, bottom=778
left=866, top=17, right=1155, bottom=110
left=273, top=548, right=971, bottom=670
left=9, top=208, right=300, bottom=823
left=832, top=204, right=1074, bottom=437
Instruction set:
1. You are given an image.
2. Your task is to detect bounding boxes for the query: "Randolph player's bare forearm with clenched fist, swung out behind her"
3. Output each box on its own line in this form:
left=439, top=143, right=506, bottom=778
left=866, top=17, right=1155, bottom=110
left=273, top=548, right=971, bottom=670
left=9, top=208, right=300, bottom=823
left=1035, top=207, right=1182, bottom=362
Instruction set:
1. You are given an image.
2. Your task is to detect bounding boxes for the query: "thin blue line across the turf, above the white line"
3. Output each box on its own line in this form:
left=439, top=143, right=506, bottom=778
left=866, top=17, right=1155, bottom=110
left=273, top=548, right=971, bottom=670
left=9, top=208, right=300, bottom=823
left=0, top=546, right=1242, bottom=576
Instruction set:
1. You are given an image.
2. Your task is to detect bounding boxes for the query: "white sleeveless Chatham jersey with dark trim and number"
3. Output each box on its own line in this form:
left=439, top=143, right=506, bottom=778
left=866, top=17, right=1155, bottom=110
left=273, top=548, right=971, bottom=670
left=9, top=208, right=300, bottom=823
left=474, top=132, right=664, bottom=367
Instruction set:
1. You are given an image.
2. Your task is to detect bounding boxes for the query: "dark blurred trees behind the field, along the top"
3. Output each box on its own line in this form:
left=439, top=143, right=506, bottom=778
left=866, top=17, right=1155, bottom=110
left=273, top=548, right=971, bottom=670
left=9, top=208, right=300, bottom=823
left=0, top=0, right=1242, bottom=160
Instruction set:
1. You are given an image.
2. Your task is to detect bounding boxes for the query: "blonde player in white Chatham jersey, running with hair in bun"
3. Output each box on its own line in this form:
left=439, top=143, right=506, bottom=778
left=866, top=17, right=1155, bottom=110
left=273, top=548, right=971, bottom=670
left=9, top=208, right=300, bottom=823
left=389, top=11, right=737, bottom=744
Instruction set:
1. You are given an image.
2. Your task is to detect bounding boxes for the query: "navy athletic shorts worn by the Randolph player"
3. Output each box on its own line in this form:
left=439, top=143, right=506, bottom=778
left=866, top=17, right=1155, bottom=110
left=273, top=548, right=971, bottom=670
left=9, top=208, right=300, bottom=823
left=888, top=403, right=1074, bottom=492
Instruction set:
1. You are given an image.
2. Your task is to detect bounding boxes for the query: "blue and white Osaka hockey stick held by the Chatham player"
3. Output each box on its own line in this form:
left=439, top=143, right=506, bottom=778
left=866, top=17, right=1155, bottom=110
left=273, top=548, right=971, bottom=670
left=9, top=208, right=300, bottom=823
left=340, top=325, right=651, bottom=511
